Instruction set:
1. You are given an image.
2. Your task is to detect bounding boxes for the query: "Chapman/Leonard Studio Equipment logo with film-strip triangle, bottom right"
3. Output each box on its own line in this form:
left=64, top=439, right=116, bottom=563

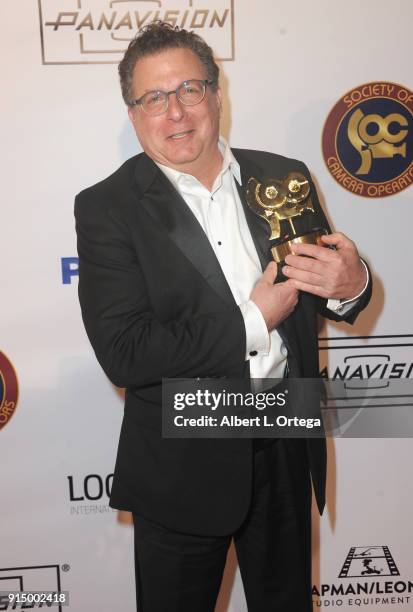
left=313, top=545, right=413, bottom=610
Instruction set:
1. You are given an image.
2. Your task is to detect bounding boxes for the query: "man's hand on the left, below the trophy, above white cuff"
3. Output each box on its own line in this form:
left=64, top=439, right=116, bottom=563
left=250, top=261, right=298, bottom=331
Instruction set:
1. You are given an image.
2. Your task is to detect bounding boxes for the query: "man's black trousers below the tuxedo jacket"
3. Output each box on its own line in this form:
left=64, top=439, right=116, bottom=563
left=134, top=439, right=312, bottom=612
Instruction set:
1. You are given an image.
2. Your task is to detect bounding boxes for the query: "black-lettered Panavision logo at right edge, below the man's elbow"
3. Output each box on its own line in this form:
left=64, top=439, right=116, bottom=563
left=319, top=334, right=413, bottom=438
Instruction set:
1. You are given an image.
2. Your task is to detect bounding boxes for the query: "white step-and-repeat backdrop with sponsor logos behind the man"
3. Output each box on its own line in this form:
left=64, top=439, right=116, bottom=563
left=0, top=0, right=413, bottom=612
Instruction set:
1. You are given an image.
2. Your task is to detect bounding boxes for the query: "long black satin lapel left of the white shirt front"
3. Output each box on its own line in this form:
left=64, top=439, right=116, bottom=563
left=135, top=155, right=235, bottom=306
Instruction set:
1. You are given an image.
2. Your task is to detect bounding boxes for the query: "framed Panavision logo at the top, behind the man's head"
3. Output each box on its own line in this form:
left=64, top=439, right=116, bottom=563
left=38, top=0, right=234, bottom=64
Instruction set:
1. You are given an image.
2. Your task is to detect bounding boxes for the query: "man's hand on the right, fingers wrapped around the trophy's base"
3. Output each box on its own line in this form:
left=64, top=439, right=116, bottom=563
left=283, top=232, right=367, bottom=299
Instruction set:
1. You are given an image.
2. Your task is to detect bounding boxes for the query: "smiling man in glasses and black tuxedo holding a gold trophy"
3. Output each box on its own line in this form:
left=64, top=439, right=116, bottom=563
left=75, top=22, right=370, bottom=612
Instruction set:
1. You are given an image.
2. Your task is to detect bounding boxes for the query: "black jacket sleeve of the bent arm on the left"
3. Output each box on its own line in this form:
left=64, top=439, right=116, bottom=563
left=75, top=191, right=246, bottom=387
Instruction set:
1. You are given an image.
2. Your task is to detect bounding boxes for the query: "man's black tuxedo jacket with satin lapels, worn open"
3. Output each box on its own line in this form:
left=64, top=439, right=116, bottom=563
left=75, top=149, right=370, bottom=535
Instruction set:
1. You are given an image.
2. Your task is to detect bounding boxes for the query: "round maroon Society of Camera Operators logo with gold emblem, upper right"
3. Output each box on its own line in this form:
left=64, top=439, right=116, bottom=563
left=322, top=81, right=413, bottom=198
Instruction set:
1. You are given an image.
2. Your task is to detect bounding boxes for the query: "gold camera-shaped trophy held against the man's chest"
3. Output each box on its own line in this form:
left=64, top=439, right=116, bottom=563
left=246, top=172, right=328, bottom=272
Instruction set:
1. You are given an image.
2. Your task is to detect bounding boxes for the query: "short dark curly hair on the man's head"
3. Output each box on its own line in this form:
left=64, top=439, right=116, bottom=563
left=118, top=21, right=219, bottom=106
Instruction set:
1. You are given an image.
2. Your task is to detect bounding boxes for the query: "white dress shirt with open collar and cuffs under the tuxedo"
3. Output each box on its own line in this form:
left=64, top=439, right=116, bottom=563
left=157, top=138, right=366, bottom=378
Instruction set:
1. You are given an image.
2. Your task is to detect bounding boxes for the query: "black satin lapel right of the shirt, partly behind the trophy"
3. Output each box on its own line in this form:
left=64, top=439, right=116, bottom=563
left=233, top=150, right=300, bottom=357
